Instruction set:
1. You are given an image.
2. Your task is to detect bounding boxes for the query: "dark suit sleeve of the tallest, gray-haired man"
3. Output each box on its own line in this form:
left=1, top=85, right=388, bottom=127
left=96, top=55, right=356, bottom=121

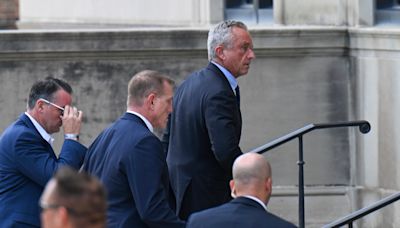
left=204, top=91, right=242, bottom=173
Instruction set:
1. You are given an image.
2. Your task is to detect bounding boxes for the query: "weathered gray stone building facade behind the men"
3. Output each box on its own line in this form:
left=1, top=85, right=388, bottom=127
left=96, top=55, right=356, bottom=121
left=0, top=0, right=400, bottom=227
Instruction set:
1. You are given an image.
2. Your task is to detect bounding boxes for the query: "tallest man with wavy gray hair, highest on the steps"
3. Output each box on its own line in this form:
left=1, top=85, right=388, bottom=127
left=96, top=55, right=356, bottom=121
left=163, top=20, right=255, bottom=219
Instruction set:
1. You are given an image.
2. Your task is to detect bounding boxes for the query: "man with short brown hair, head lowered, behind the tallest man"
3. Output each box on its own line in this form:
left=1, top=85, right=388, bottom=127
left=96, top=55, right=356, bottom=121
left=83, top=70, right=185, bottom=228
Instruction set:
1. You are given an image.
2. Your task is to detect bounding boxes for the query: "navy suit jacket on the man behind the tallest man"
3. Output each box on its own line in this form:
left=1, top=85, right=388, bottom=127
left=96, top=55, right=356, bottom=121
left=83, top=113, right=184, bottom=228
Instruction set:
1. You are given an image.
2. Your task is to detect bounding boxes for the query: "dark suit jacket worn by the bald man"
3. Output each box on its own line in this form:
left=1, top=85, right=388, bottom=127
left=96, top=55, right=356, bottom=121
left=186, top=197, right=296, bottom=228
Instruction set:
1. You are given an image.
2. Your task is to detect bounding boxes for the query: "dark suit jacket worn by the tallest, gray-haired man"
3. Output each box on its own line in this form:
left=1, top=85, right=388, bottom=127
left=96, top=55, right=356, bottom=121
left=163, top=63, right=242, bottom=217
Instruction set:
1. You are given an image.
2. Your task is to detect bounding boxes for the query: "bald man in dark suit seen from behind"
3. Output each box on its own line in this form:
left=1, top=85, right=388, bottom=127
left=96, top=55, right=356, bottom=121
left=187, top=153, right=296, bottom=228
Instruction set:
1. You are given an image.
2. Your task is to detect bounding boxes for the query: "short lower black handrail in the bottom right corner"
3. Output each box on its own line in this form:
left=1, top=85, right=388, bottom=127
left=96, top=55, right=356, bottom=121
left=323, top=192, right=400, bottom=228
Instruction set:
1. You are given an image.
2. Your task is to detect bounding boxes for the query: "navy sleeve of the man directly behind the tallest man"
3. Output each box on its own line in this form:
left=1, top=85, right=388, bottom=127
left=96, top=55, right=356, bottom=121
left=125, top=136, right=185, bottom=228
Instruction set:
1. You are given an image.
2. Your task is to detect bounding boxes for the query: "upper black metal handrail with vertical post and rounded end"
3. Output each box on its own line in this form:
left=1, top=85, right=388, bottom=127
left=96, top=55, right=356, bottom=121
left=249, top=120, right=371, bottom=228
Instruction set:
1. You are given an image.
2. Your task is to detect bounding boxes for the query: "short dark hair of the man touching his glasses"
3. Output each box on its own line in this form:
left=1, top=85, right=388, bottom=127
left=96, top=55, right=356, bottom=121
left=28, top=77, right=72, bottom=109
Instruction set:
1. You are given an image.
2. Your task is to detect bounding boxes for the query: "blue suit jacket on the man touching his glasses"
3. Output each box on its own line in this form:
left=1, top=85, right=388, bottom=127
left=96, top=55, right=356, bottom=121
left=0, top=114, right=86, bottom=227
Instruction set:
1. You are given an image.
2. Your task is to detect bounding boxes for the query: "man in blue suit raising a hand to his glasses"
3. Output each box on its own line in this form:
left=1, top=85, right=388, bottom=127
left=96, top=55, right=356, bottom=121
left=0, top=78, right=86, bottom=227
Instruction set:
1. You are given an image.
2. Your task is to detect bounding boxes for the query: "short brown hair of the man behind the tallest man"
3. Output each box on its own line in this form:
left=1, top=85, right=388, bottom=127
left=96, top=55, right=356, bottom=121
left=127, top=70, right=175, bottom=106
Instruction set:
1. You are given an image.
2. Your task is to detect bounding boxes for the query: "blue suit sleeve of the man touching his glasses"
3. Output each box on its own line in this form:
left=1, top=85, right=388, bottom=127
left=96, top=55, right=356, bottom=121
left=15, top=132, right=86, bottom=186
